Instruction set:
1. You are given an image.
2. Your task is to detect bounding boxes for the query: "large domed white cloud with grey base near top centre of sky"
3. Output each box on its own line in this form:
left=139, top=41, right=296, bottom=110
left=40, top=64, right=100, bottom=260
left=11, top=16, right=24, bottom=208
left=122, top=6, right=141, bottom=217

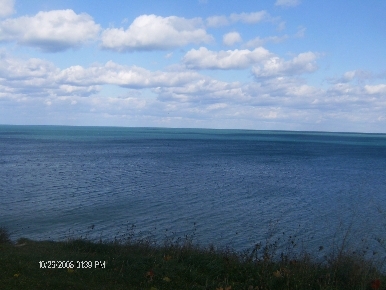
left=102, top=14, right=213, bottom=52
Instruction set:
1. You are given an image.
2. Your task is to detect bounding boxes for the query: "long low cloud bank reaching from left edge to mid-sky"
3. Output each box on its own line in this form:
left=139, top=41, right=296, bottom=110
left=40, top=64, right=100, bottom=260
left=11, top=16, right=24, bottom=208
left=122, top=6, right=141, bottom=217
left=0, top=50, right=207, bottom=93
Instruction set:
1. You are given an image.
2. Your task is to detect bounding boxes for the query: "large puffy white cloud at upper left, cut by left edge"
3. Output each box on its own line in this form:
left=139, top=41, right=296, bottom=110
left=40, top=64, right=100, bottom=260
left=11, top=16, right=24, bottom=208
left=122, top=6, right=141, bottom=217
left=0, top=9, right=100, bottom=52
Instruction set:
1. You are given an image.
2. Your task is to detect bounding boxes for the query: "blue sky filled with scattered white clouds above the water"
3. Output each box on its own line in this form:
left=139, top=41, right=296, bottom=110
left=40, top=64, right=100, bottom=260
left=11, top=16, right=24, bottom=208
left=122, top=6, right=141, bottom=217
left=0, top=0, right=386, bottom=133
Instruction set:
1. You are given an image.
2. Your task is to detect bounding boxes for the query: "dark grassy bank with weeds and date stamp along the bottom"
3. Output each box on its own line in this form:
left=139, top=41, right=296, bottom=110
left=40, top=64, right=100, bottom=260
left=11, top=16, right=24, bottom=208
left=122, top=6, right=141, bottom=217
left=0, top=227, right=386, bottom=290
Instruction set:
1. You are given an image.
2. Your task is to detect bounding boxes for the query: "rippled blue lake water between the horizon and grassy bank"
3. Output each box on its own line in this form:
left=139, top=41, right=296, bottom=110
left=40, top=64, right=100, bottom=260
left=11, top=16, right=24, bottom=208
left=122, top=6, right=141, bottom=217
left=0, top=125, right=386, bottom=258
